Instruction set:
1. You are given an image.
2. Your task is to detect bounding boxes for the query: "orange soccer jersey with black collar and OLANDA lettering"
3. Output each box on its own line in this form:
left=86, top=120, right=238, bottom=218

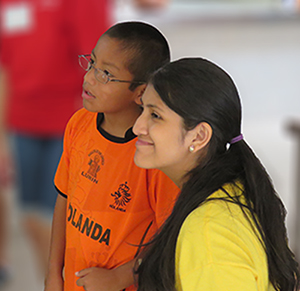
left=55, top=109, right=178, bottom=291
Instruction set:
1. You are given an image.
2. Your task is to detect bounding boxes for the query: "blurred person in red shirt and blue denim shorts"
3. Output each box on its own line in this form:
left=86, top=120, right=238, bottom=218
left=0, top=0, right=112, bottom=276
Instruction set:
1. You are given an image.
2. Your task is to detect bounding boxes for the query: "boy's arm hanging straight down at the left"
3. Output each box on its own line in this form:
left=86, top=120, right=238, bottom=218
left=45, top=195, right=67, bottom=291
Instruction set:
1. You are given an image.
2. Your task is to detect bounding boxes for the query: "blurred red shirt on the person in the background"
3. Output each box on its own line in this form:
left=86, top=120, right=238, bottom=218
left=0, top=0, right=110, bottom=136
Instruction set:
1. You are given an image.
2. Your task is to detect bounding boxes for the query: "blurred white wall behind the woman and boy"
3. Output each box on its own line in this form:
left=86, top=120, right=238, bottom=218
left=117, top=3, right=300, bottom=250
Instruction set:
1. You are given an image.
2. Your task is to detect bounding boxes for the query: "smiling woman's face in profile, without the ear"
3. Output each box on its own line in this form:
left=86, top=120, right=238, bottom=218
left=133, top=85, right=195, bottom=183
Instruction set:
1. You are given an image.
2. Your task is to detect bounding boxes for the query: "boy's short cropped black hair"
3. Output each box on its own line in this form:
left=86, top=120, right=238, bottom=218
left=103, top=21, right=170, bottom=90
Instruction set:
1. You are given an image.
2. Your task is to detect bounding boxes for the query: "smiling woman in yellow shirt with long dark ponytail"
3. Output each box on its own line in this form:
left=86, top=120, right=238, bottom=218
left=133, top=58, right=299, bottom=291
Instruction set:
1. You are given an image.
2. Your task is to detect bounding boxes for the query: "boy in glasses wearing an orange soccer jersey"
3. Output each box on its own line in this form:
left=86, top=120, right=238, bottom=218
left=45, top=22, right=178, bottom=291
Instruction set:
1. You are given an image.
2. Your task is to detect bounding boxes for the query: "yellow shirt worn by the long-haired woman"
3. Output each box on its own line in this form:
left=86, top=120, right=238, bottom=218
left=176, top=185, right=274, bottom=291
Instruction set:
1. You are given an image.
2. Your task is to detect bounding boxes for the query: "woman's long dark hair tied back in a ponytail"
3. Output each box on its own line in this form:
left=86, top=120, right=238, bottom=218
left=136, top=58, right=299, bottom=291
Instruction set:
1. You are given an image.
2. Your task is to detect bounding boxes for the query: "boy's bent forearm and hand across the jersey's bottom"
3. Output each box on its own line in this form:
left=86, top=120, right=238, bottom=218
left=76, top=260, right=136, bottom=291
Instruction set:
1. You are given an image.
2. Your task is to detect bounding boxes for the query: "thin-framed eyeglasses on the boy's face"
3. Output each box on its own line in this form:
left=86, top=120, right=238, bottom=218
left=78, top=55, right=145, bottom=84
